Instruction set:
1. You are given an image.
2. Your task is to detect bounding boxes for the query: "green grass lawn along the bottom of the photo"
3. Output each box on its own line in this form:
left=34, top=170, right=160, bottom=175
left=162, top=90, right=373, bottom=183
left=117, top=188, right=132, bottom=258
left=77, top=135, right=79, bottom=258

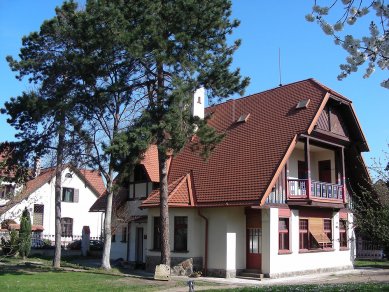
left=0, top=258, right=389, bottom=292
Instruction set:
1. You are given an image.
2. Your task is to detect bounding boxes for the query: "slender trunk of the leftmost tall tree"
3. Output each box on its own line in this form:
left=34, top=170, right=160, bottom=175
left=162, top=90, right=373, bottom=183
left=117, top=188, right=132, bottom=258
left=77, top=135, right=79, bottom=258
left=53, top=118, right=65, bottom=268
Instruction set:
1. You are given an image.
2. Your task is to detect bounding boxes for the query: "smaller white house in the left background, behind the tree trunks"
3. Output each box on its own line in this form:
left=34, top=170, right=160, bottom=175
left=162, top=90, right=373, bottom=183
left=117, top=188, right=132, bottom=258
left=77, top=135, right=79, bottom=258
left=0, top=166, right=105, bottom=238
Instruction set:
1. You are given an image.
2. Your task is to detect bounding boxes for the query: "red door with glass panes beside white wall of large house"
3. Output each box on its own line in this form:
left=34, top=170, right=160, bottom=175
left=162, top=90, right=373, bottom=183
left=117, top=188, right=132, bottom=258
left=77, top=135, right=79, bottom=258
left=246, top=210, right=262, bottom=270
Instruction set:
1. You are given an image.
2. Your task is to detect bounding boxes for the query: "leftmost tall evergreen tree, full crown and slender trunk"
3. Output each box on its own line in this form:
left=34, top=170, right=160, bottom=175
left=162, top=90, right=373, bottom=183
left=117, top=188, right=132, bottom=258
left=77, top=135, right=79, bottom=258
left=2, top=2, right=84, bottom=268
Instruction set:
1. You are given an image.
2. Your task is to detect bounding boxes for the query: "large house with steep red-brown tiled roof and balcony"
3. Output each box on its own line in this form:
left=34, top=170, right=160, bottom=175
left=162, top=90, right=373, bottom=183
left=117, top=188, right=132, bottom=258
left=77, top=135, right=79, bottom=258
left=91, top=79, right=368, bottom=277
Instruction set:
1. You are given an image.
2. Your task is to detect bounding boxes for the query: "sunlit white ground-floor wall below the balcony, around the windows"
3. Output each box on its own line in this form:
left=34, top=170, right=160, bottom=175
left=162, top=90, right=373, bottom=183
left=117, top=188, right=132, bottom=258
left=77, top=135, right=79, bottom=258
left=262, top=208, right=352, bottom=277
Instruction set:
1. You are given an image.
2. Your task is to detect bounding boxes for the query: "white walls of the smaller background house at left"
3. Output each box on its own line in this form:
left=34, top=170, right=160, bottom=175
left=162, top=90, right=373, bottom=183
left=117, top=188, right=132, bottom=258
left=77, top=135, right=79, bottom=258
left=0, top=169, right=102, bottom=237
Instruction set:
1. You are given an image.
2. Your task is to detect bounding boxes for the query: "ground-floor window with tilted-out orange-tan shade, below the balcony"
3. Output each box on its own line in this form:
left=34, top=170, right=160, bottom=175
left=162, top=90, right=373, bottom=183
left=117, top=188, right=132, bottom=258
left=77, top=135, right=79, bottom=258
left=299, top=218, right=332, bottom=250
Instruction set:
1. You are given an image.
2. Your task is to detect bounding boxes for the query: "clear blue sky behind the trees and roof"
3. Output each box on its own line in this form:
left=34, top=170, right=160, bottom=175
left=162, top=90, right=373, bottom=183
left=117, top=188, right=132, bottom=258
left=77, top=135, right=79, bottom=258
left=0, top=0, right=389, bottom=171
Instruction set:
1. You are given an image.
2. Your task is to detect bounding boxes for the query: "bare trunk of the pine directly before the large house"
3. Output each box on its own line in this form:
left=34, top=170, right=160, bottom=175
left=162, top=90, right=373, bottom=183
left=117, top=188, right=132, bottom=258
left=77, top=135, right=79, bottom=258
left=158, top=149, right=170, bottom=266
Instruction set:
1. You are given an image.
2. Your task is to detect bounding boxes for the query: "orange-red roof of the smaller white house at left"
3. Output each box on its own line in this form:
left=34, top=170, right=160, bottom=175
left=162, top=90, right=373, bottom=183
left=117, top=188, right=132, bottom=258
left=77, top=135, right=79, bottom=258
left=0, top=166, right=105, bottom=215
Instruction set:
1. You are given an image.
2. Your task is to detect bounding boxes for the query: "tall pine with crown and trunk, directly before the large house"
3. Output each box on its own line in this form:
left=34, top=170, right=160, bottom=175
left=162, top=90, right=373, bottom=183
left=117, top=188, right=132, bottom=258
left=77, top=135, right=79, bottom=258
left=108, top=0, right=249, bottom=265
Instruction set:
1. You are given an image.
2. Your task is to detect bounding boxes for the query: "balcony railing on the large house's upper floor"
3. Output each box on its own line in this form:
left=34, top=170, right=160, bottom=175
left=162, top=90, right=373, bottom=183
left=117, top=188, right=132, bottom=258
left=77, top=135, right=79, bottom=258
left=288, top=179, right=344, bottom=201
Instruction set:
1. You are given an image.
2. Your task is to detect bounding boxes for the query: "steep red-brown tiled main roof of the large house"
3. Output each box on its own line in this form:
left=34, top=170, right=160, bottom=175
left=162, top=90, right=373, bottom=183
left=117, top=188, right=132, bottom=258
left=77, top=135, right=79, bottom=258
left=141, top=79, right=368, bottom=207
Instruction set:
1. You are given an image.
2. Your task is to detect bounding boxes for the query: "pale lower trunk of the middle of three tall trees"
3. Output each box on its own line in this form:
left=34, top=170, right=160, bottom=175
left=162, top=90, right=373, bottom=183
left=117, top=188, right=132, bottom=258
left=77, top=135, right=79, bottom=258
left=101, top=179, right=113, bottom=270
